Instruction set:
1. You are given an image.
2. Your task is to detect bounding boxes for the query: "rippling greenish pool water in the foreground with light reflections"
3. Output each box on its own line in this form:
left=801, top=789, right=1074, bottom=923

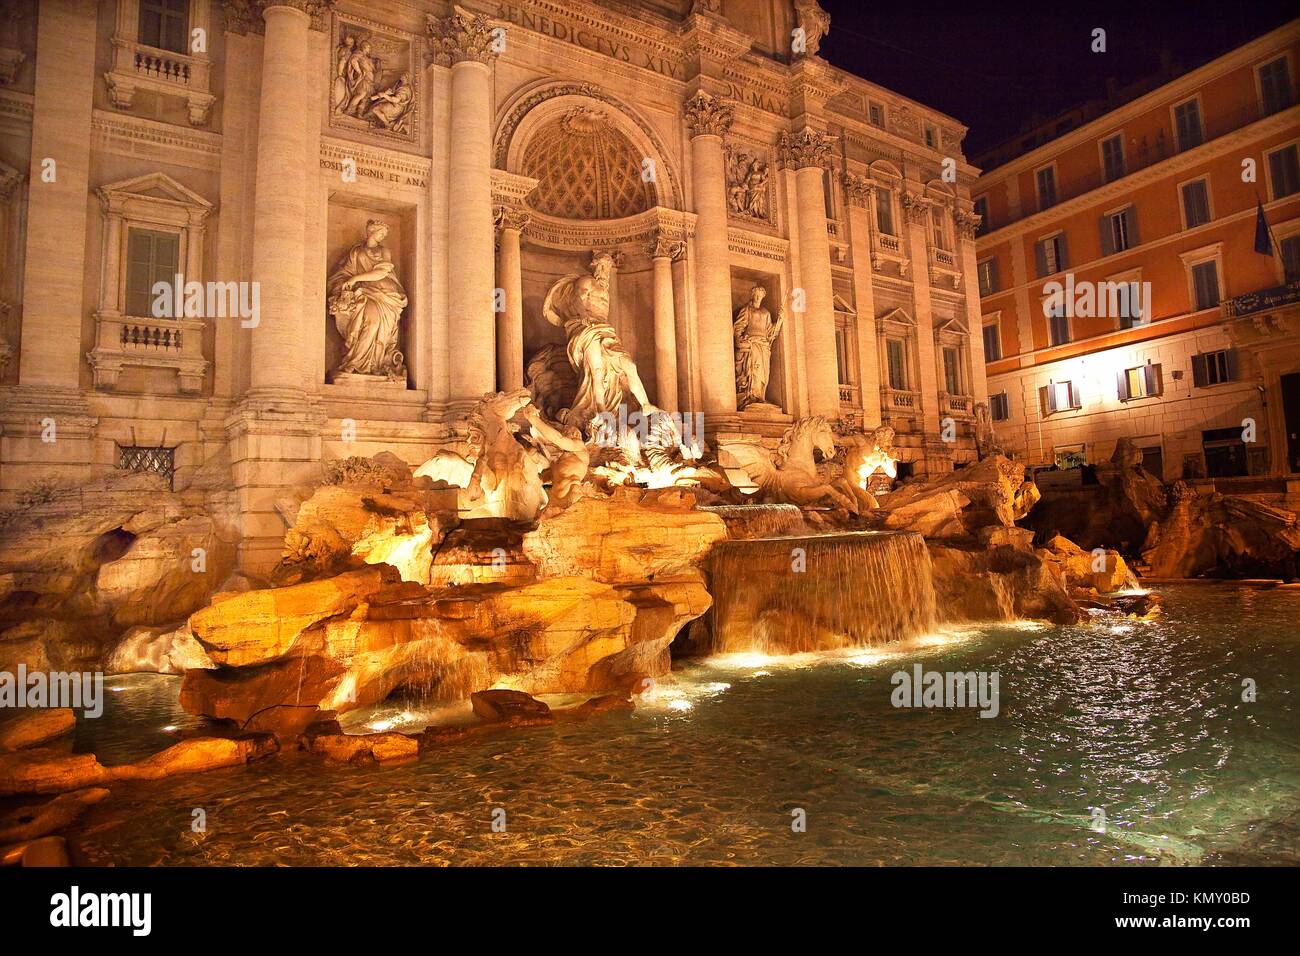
left=61, top=587, right=1300, bottom=865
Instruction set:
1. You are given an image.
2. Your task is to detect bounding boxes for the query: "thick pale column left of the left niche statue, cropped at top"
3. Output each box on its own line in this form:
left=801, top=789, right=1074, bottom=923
left=248, top=0, right=330, bottom=402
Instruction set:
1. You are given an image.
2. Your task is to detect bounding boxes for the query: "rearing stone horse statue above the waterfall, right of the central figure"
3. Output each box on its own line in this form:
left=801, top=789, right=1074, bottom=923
left=718, top=415, right=859, bottom=514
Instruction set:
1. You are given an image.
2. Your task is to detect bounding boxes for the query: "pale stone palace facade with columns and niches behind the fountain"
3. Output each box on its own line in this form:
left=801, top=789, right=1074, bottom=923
left=0, top=0, right=985, bottom=566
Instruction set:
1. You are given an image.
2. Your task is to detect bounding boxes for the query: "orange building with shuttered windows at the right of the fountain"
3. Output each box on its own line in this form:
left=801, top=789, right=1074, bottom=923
left=972, top=22, right=1300, bottom=480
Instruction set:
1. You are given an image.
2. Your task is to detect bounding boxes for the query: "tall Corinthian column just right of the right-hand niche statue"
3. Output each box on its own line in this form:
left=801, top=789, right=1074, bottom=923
left=780, top=126, right=840, bottom=418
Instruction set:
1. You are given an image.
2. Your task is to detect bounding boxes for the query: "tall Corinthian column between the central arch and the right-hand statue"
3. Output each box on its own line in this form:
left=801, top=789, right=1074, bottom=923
left=685, top=90, right=738, bottom=415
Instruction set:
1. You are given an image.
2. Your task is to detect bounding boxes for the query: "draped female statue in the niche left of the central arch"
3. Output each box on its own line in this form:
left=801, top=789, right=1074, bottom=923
left=328, top=219, right=407, bottom=381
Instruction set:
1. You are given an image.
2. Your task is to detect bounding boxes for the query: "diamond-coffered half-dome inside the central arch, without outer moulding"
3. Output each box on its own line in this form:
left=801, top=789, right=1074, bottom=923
left=520, top=105, right=657, bottom=220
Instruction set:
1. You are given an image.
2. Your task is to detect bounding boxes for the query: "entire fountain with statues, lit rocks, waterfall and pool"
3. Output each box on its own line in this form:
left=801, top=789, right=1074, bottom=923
left=0, top=243, right=1300, bottom=865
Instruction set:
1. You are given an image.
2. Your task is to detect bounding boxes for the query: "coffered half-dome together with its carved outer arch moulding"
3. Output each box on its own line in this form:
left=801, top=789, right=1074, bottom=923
left=493, top=83, right=685, bottom=219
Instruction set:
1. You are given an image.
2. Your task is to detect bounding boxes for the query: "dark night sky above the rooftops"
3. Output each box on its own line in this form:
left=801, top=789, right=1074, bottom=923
left=820, top=0, right=1297, bottom=157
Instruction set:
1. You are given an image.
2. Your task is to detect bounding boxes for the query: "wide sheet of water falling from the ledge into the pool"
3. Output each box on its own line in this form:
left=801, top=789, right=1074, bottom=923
left=707, top=532, right=935, bottom=654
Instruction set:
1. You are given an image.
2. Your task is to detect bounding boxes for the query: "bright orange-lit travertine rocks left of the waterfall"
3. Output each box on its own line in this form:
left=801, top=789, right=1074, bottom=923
left=181, top=489, right=725, bottom=735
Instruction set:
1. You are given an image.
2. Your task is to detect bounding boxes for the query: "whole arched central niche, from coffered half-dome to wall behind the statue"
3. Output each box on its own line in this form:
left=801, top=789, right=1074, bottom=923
left=493, top=82, right=686, bottom=408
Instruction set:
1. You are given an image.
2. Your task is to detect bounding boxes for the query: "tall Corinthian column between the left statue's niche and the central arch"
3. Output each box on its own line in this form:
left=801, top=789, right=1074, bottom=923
left=426, top=8, right=501, bottom=402
